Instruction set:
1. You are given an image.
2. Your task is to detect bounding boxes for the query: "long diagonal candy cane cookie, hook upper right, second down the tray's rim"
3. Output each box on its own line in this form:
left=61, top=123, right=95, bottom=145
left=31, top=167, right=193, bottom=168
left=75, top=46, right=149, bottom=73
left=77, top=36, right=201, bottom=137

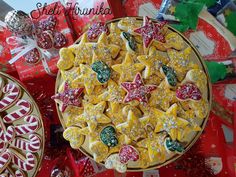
left=3, top=100, right=31, bottom=123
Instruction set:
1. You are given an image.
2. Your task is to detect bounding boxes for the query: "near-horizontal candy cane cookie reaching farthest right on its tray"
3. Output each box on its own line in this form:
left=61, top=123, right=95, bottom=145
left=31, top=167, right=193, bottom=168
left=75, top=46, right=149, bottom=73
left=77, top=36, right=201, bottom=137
left=11, top=134, right=41, bottom=152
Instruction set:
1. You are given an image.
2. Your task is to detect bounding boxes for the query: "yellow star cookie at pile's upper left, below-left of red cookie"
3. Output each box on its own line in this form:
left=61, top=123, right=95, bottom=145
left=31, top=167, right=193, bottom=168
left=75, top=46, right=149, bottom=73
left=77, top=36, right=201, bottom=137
left=69, top=33, right=93, bottom=66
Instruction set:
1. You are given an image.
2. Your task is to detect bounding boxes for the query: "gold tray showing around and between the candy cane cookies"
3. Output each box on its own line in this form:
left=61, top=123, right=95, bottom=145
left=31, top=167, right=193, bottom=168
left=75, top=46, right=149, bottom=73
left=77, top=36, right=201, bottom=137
left=0, top=72, right=45, bottom=177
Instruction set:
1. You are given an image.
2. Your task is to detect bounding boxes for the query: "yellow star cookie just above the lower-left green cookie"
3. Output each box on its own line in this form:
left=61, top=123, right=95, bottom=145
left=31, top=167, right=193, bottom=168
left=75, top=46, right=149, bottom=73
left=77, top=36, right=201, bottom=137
left=77, top=101, right=111, bottom=132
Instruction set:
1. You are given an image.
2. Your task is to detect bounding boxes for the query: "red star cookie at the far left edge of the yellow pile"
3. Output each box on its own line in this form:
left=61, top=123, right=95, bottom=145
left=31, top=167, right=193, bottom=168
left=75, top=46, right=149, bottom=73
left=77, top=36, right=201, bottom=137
left=52, top=82, right=84, bottom=112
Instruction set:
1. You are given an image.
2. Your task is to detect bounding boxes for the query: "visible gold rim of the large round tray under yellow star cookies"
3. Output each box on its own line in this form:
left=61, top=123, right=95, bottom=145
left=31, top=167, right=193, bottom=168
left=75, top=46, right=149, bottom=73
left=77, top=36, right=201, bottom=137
left=55, top=17, right=212, bottom=171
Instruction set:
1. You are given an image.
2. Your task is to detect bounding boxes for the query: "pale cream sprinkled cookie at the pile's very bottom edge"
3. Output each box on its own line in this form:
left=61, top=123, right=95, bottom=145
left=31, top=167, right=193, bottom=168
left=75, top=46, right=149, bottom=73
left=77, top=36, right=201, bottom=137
left=105, top=154, right=127, bottom=173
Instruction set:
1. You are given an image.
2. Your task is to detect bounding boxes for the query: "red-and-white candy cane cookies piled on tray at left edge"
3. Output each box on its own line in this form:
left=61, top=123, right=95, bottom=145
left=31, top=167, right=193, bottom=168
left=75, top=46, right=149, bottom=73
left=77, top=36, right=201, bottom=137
left=0, top=75, right=44, bottom=177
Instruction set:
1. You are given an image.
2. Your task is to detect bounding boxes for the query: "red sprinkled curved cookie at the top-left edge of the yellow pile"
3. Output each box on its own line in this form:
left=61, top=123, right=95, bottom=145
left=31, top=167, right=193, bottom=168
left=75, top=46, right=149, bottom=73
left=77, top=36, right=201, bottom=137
left=87, top=22, right=109, bottom=41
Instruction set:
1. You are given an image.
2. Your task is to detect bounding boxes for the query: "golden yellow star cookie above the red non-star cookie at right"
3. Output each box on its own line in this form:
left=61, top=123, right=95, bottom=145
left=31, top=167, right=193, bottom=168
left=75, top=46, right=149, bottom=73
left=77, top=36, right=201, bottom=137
left=167, top=47, right=199, bottom=81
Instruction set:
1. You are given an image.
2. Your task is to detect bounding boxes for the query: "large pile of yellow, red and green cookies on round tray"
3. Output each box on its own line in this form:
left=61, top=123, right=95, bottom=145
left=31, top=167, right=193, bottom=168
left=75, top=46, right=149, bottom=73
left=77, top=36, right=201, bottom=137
left=52, top=17, right=209, bottom=172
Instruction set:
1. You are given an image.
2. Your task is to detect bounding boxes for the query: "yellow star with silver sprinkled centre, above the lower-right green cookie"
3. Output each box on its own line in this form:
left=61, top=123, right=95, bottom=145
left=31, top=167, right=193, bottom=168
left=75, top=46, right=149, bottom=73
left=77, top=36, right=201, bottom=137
left=155, top=104, right=188, bottom=141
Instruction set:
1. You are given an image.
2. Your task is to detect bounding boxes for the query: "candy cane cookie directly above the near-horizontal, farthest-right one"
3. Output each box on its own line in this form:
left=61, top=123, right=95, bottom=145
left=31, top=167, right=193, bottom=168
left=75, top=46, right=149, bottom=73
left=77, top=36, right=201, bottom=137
left=15, top=115, right=40, bottom=135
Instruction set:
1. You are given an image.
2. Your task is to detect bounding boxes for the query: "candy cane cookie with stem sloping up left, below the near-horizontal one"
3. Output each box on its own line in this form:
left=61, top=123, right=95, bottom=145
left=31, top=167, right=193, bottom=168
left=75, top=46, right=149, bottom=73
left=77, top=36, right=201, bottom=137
left=11, top=149, right=36, bottom=171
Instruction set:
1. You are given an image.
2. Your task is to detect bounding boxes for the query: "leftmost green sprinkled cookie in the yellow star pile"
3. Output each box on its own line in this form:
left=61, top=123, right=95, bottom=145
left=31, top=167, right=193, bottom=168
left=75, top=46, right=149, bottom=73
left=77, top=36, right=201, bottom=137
left=91, top=61, right=111, bottom=83
